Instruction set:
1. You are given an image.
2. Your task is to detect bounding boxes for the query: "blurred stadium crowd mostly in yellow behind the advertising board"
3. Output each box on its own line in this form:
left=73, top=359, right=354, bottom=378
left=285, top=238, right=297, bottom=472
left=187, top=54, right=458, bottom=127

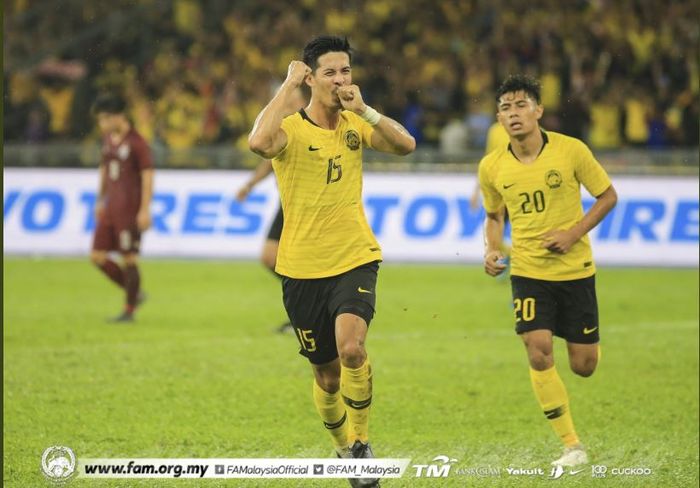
left=3, top=0, right=700, bottom=151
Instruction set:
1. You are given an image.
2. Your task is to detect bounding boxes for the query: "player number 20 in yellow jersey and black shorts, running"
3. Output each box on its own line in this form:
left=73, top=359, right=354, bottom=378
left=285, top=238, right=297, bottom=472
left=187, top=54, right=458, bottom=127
left=479, top=75, right=617, bottom=466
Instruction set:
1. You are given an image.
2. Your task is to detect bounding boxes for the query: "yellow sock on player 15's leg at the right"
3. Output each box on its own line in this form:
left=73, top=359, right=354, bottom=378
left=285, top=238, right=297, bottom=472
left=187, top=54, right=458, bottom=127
left=340, top=359, right=372, bottom=444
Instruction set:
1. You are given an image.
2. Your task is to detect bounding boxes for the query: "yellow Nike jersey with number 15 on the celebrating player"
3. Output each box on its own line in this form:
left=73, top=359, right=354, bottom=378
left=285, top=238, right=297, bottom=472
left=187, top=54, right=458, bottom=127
left=272, top=110, right=382, bottom=279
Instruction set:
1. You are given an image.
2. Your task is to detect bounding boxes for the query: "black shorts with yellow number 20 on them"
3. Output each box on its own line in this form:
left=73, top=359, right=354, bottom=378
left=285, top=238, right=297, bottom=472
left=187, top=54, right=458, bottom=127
left=510, top=276, right=600, bottom=344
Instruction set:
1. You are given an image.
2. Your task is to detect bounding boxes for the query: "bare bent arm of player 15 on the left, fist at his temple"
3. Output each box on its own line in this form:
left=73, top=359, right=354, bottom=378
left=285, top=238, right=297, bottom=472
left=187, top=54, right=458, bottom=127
left=248, top=61, right=311, bottom=159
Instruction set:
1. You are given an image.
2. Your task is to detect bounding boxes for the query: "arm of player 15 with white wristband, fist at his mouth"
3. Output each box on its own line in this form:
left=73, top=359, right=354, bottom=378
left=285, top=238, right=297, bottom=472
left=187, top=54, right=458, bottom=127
left=338, top=85, right=416, bottom=156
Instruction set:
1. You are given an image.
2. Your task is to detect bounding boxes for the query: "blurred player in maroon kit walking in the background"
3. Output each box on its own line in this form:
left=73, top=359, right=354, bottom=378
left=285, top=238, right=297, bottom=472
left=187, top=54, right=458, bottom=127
left=90, top=94, right=153, bottom=322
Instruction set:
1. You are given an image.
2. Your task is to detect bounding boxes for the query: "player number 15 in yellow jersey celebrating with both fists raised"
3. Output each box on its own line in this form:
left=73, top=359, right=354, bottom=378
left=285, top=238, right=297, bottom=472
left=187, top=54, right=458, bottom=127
left=249, top=36, right=415, bottom=486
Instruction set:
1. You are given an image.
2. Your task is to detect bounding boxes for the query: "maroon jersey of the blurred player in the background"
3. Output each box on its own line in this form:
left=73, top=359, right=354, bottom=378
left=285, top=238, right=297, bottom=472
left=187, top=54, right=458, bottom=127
left=100, top=128, right=153, bottom=220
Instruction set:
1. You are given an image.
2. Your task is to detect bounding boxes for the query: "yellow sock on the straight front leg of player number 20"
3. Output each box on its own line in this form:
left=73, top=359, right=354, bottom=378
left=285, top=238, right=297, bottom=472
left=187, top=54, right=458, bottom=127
left=530, top=366, right=579, bottom=447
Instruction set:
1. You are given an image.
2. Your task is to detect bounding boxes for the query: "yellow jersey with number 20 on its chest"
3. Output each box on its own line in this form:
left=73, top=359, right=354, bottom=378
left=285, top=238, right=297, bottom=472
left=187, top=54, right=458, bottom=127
left=479, top=131, right=611, bottom=281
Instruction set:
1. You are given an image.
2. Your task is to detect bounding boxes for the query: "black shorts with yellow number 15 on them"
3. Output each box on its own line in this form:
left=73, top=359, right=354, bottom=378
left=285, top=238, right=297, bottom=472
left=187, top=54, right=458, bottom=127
left=282, top=261, right=379, bottom=364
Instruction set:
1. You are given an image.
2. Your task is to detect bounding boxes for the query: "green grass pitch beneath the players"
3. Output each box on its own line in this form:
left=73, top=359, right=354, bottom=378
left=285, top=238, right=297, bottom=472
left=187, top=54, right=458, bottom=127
left=3, top=258, right=699, bottom=488
